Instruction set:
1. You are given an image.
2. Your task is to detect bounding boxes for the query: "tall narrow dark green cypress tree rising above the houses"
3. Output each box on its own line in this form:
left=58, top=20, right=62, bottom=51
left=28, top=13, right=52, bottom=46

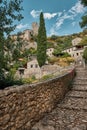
left=37, top=12, right=47, bottom=67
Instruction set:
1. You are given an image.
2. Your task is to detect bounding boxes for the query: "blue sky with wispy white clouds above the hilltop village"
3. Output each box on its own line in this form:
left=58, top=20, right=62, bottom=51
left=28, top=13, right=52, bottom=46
left=13, top=0, right=86, bottom=36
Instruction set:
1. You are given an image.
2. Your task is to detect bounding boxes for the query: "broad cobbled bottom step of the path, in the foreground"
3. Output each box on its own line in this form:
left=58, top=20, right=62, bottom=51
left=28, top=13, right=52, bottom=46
left=31, top=108, right=87, bottom=130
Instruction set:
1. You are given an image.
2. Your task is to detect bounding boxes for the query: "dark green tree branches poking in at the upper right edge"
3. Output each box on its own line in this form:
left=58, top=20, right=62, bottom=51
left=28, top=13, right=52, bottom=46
left=80, top=0, right=87, bottom=28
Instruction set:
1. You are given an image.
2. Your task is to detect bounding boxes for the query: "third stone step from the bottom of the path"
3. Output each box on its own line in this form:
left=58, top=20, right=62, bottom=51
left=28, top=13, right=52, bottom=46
left=66, top=90, right=87, bottom=98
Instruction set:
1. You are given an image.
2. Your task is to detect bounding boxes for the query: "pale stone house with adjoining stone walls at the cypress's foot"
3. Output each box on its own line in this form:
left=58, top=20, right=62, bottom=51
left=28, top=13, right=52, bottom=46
left=16, top=58, right=60, bottom=79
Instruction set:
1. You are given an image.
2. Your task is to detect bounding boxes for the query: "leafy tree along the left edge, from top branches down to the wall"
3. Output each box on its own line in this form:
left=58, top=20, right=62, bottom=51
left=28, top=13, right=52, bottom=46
left=0, top=0, right=23, bottom=87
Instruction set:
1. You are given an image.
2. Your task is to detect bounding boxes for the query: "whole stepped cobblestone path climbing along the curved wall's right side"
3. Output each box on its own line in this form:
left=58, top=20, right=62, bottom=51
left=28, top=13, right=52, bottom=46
left=32, top=68, right=87, bottom=130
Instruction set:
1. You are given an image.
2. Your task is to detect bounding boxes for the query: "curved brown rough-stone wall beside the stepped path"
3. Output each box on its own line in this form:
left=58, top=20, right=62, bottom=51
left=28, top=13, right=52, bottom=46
left=0, top=70, right=75, bottom=130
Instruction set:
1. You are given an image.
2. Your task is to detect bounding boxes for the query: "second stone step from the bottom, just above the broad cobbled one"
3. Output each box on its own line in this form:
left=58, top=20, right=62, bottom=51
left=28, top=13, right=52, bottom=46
left=58, top=97, right=87, bottom=111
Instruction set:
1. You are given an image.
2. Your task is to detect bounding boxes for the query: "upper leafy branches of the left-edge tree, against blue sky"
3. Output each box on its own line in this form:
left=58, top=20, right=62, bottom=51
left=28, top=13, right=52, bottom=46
left=0, top=0, right=23, bottom=34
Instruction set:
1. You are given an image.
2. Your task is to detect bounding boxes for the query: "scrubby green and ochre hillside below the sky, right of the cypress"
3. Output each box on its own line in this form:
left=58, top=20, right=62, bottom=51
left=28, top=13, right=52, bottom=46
left=47, top=29, right=87, bottom=50
